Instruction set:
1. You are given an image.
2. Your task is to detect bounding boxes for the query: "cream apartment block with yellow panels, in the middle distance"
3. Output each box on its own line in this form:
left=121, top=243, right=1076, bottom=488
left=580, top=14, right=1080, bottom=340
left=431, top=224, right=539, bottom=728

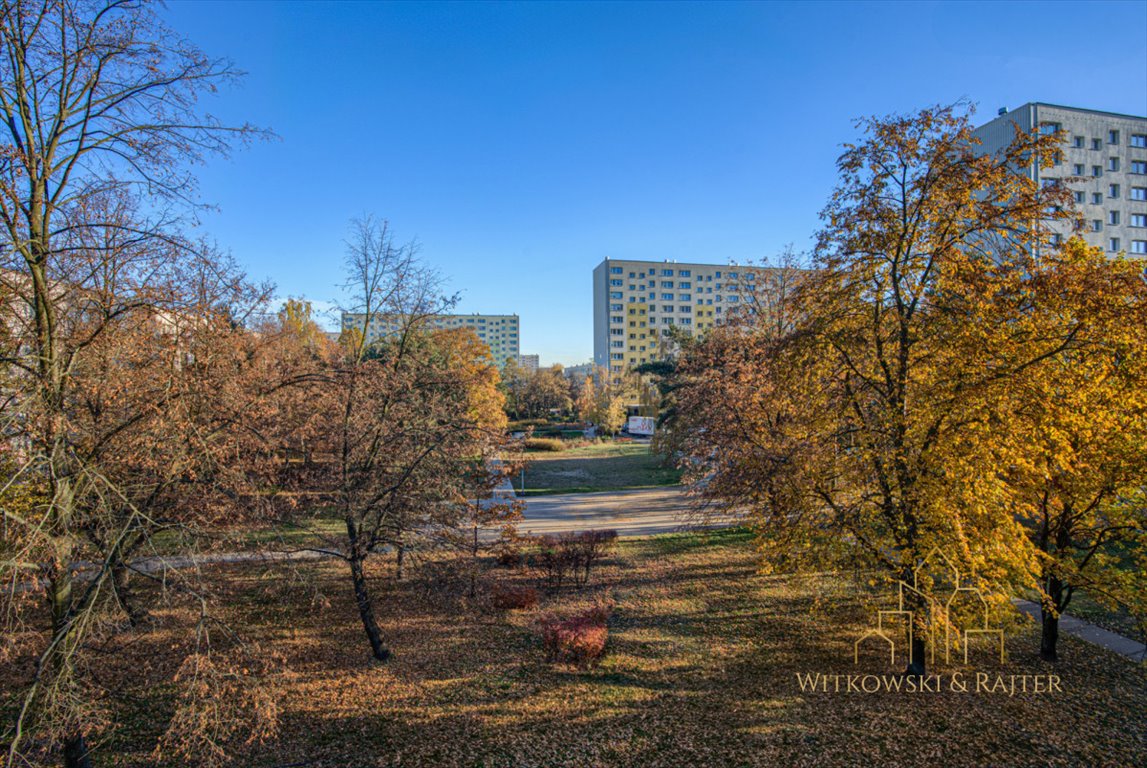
left=593, top=259, right=767, bottom=374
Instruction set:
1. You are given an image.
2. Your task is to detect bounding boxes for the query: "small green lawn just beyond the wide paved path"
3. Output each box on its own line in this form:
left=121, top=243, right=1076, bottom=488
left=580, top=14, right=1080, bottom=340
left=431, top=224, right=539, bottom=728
left=523, top=442, right=681, bottom=495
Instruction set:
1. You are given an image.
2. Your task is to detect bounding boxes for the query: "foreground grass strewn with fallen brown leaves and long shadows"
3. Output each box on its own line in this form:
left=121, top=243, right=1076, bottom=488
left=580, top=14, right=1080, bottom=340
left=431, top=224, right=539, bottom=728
left=0, top=531, right=1147, bottom=768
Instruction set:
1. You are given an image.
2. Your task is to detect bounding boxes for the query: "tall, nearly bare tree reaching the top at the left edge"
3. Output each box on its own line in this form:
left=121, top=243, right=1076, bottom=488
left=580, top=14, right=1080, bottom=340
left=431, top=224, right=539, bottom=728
left=0, top=0, right=269, bottom=766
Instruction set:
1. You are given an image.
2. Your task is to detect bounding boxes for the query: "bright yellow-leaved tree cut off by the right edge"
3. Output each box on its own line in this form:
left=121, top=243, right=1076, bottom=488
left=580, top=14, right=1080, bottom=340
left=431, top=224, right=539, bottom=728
left=984, top=238, right=1147, bottom=660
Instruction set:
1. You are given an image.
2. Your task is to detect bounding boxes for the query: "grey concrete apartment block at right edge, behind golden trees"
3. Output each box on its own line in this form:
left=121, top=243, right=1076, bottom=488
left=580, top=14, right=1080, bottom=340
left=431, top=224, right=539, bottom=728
left=974, top=102, right=1147, bottom=258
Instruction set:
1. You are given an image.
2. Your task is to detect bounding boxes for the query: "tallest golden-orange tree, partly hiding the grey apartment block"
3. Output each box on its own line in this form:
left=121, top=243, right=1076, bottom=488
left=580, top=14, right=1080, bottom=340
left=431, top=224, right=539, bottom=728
left=676, top=108, right=1070, bottom=674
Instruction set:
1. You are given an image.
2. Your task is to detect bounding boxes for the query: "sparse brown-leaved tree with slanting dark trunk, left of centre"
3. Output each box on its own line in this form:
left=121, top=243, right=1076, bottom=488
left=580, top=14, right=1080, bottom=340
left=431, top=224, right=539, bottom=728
left=285, top=218, right=506, bottom=661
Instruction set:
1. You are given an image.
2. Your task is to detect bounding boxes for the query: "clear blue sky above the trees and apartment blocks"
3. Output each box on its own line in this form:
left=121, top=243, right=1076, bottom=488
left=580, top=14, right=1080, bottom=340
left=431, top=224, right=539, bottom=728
left=165, top=0, right=1147, bottom=365
